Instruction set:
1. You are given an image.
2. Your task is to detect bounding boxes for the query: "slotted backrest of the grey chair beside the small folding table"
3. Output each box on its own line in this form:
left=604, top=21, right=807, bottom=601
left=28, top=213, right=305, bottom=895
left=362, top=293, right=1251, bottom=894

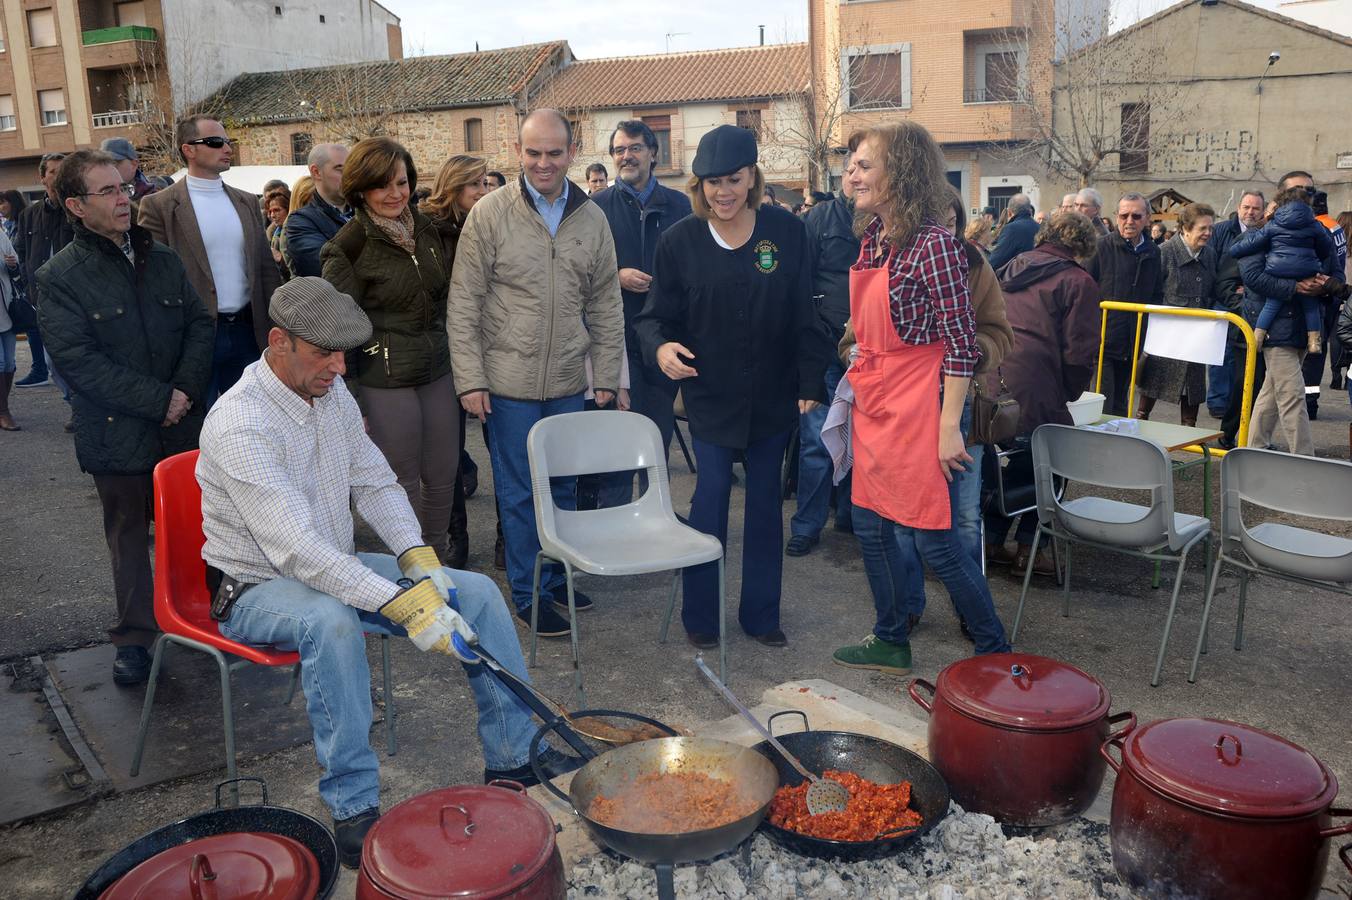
left=1033, top=424, right=1183, bottom=550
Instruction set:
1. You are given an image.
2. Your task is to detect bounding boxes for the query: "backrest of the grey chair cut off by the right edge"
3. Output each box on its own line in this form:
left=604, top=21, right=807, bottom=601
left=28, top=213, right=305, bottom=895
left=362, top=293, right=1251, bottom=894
left=1221, top=447, right=1352, bottom=580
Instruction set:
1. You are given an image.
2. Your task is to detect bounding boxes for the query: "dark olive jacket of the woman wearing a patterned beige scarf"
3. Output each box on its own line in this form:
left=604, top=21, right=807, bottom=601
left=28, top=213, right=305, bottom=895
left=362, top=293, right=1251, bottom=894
left=320, top=209, right=450, bottom=393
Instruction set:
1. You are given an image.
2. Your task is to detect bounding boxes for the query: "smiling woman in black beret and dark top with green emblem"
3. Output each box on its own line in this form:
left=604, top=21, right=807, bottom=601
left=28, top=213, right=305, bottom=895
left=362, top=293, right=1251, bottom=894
left=635, top=126, right=831, bottom=647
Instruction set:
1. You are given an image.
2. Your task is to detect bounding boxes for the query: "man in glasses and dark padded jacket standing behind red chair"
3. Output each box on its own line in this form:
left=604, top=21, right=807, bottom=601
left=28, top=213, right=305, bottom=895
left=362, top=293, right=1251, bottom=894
left=35, top=150, right=214, bottom=685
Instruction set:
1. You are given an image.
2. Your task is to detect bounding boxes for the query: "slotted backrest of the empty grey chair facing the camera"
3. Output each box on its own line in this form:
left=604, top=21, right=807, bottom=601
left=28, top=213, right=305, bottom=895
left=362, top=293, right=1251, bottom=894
left=526, top=409, right=676, bottom=550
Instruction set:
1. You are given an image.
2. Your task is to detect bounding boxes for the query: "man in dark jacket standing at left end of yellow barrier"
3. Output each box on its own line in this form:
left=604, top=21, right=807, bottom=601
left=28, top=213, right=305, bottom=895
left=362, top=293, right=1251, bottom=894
left=1086, top=191, right=1164, bottom=416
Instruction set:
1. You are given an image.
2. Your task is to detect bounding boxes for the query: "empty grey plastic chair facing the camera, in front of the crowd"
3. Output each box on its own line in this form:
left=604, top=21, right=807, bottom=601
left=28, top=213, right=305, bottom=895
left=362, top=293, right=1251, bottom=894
left=526, top=409, right=727, bottom=703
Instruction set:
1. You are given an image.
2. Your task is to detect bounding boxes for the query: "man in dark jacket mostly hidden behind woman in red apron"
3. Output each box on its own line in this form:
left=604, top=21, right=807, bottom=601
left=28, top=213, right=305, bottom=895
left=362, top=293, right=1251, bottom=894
left=784, top=172, right=859, bottom=557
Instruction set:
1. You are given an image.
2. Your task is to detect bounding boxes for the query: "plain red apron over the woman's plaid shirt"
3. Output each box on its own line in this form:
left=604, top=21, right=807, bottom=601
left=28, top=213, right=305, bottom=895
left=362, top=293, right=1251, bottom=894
left=848, top=259, right=953, bottom=530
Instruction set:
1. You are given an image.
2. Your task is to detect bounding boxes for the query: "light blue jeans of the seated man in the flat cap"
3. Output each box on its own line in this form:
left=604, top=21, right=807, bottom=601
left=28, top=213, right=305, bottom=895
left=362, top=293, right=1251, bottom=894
left=219, top=553, right=535, bottom=819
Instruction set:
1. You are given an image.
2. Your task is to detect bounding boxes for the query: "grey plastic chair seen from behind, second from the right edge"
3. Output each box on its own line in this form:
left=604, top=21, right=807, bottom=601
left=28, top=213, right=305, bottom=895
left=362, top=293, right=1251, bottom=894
left=1010, top=424, right=1211, bottom=688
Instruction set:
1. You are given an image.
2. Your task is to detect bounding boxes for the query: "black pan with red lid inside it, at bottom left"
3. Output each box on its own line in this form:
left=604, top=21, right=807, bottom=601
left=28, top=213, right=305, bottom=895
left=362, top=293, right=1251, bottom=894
left=73, top=778, right=338, bottom=900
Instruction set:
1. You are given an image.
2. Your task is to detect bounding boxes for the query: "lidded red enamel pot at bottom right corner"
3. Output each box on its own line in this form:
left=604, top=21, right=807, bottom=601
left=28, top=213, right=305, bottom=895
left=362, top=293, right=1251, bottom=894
left=1102, top=719, right=1352, bottom=900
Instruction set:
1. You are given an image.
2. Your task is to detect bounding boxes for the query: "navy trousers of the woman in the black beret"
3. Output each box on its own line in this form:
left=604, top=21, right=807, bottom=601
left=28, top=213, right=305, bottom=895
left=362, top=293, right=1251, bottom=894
left=681, top=431, right=791, bottom=635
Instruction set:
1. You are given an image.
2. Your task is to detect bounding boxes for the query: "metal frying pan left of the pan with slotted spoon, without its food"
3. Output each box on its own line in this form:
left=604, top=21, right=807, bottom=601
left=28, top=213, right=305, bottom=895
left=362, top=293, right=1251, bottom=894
left=530, top=714, right=779, bottom=900
